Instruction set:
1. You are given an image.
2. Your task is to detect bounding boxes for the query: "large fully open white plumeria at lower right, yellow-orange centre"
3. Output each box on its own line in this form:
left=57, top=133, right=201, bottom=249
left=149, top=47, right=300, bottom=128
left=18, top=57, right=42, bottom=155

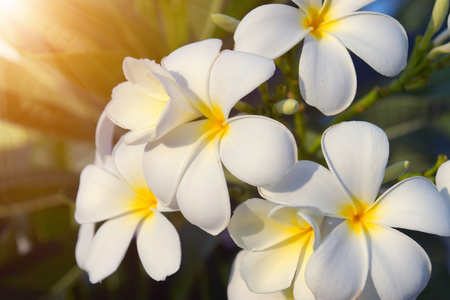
left=260, top=122, right=450, bottom=299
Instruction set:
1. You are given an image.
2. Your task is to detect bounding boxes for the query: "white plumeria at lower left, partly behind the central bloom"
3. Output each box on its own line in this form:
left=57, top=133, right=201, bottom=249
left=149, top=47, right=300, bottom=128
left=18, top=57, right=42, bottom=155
left=75, top=140, right=181, bottom=283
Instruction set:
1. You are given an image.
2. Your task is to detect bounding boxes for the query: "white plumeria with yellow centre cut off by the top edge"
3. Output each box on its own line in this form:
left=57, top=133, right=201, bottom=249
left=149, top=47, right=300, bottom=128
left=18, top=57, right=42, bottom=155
left=234, top=0, right=408, bottom=115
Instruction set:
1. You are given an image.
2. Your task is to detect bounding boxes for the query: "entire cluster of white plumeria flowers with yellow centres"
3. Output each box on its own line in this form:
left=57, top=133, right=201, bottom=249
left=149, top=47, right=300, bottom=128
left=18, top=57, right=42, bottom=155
left=75, top=0, right=450, bottom=299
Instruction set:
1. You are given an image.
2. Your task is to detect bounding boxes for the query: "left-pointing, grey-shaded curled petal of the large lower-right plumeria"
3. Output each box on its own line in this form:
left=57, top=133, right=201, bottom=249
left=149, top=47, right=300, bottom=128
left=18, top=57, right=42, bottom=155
left=259, top=160, right=348, bottom=214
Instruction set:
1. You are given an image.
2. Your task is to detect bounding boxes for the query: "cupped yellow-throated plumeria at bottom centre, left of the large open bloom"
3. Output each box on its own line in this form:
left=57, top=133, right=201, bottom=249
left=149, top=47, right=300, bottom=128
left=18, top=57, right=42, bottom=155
left=228, top=198, right=323, bottom=299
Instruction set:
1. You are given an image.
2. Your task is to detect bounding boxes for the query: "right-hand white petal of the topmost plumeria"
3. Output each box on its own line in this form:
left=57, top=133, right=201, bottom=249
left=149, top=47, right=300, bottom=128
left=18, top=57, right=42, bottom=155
left=329, top=12, right=408, bottom=76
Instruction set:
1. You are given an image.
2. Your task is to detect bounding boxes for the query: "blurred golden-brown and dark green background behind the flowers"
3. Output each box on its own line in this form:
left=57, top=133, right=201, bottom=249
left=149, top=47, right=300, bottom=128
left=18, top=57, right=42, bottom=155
left=0, top=0, right=450, bottom=299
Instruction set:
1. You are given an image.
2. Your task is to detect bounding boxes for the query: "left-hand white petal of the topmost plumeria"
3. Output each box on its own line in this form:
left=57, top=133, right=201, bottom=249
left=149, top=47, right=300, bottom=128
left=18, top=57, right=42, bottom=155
left=234, top=4, right=309, bottom=59
